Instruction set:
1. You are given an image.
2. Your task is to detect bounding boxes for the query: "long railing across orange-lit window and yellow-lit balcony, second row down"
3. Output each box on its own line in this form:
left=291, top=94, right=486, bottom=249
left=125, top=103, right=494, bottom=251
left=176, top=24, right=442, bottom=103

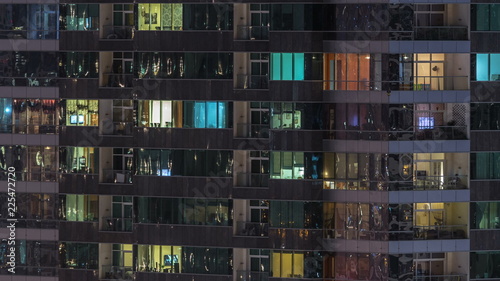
left=323, top=76, right=470, bottom=91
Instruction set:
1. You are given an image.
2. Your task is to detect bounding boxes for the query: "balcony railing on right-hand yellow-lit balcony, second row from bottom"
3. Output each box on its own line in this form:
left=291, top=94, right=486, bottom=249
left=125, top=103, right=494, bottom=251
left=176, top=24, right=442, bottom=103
left=413, top=225, right=467, bottom=240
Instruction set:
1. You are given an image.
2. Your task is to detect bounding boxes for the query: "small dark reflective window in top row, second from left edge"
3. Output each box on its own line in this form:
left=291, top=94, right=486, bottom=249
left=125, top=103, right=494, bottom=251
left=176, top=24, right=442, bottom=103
left=61, top=4, right=99, bottom=30
